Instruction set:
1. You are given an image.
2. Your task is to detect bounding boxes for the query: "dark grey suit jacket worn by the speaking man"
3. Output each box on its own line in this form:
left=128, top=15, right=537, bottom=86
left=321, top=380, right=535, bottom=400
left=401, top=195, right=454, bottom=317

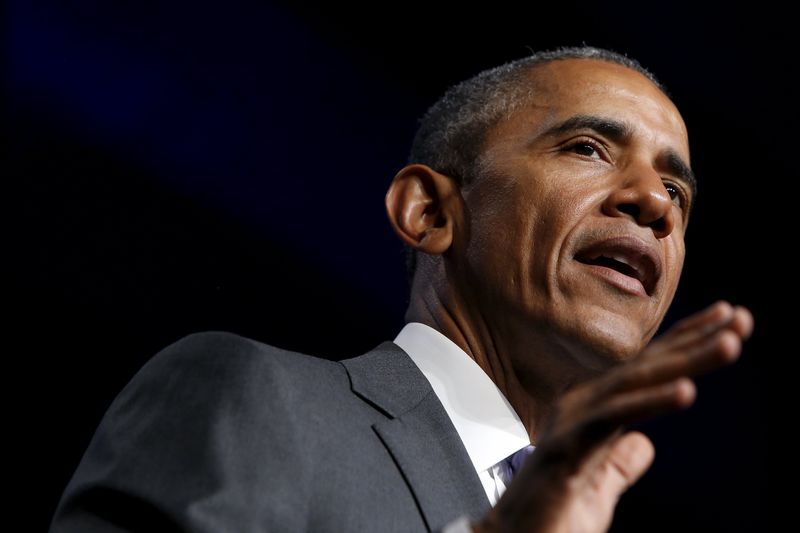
left=51, top=332, right=490, bottom=533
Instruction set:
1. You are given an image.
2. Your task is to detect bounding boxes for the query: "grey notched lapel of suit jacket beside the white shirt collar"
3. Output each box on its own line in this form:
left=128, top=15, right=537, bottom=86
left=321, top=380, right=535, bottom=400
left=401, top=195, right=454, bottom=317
left=342, top=342, right=490, bottom=531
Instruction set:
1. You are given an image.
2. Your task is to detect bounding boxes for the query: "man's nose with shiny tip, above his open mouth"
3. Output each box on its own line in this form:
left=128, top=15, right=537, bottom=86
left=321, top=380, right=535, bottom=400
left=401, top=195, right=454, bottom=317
left=603, top=167, right=675, bottom=239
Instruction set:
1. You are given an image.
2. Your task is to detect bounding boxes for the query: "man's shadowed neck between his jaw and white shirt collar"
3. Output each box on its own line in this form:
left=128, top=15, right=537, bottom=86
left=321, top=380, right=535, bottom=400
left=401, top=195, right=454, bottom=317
left=405, top=264, right=584, bottom=444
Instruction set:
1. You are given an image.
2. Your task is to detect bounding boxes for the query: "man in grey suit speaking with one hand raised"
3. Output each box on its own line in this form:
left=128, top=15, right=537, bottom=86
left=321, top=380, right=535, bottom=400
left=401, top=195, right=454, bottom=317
left=52, top=48, right=752, bottom=532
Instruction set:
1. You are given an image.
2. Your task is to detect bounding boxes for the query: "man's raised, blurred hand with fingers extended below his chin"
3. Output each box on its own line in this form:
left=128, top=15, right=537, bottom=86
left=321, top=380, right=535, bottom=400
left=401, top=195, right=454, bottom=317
left=474, top=302, right=753, bottom=533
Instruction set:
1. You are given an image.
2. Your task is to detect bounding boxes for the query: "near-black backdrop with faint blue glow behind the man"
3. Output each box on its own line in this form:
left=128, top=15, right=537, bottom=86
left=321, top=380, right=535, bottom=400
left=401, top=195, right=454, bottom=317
left=9, top=0, right=780, bottom=531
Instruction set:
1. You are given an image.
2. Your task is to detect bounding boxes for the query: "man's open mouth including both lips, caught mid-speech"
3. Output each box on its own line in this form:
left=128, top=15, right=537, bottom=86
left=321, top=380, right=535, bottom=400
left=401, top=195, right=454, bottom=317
left=575, top=237, right=661, bottom=295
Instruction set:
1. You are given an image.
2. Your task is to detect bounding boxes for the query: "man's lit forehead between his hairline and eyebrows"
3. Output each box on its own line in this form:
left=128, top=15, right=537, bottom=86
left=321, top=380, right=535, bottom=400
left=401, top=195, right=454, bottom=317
left=487, top=59, right=689, bottom=161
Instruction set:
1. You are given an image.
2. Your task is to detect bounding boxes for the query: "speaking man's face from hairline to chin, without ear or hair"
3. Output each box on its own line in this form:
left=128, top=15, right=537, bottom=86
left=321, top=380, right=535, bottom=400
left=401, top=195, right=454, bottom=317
left=457, top=59, right=693, bottom=370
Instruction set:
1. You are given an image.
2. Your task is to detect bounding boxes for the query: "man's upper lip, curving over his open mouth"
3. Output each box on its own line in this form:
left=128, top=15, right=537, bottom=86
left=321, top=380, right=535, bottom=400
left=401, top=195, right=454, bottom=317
left=575, top=235, right=662, bottom=296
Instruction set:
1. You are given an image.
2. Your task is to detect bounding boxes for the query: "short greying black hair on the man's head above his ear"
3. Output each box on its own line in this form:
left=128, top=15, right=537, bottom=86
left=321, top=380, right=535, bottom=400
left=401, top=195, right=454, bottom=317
left=405, top=46, right=669, bottom=283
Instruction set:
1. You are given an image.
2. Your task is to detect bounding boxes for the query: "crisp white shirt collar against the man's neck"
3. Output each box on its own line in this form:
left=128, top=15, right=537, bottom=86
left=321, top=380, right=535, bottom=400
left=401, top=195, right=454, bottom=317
left=394, top=322, right=530, bottom=472
